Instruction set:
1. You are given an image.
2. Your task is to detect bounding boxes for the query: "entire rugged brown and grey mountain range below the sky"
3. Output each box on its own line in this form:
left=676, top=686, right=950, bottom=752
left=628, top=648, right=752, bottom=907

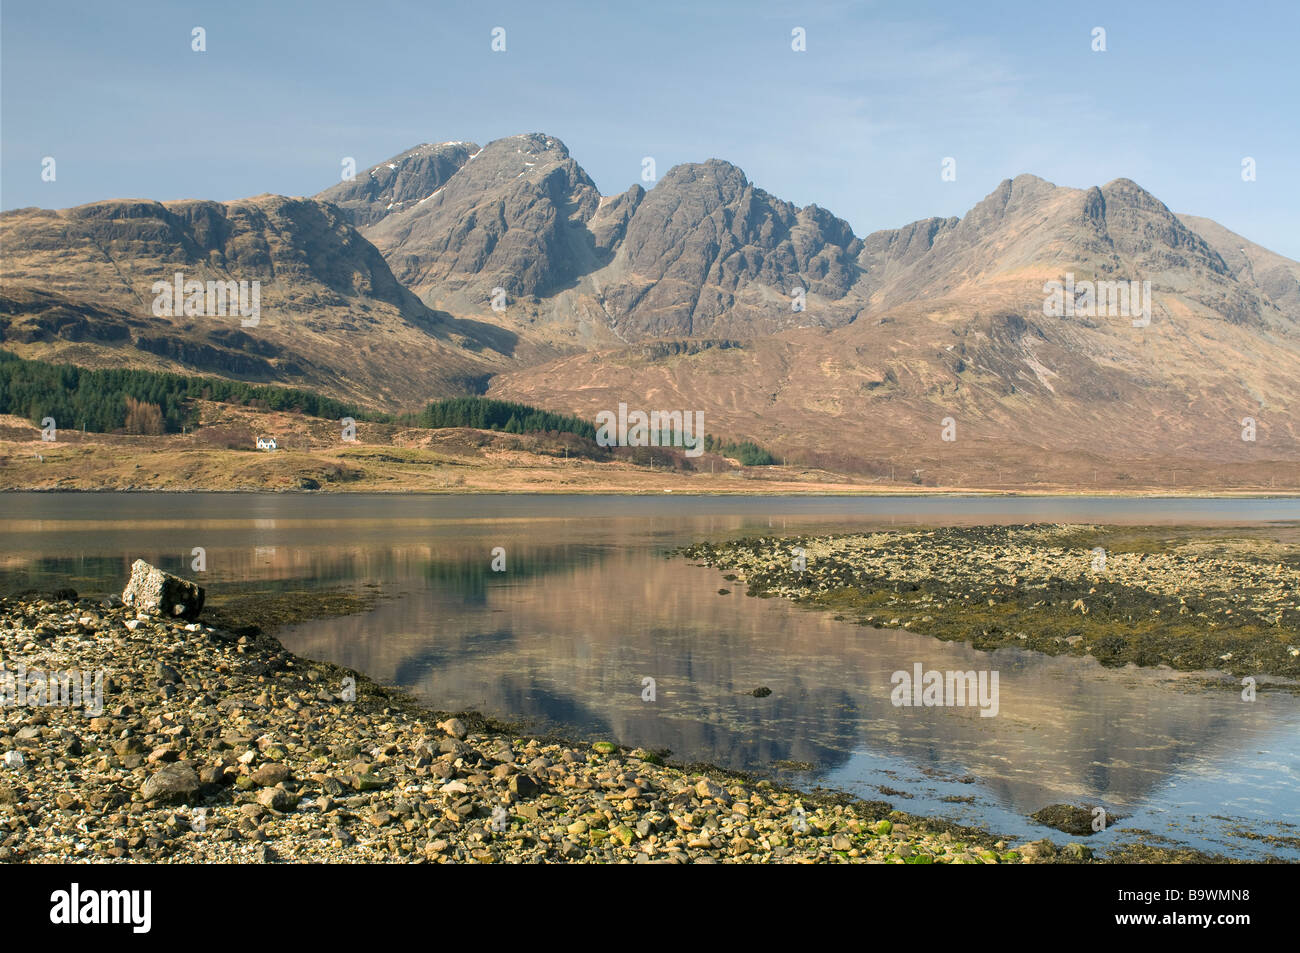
left=0, top=134, right=1300, bottom=486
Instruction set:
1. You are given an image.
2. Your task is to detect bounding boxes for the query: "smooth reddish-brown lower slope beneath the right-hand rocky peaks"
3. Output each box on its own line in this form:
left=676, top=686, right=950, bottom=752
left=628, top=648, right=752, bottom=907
left=489, top=289, right=1300, bottom=490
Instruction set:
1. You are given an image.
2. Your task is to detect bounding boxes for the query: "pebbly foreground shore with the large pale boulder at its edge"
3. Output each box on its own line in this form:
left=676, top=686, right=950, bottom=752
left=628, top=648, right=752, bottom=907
left=0, top=579, right=1258, bottom=863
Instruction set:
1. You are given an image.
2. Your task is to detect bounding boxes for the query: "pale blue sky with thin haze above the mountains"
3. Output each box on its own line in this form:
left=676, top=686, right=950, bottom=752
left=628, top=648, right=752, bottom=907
left=0, top=0, right=1300, bottom=259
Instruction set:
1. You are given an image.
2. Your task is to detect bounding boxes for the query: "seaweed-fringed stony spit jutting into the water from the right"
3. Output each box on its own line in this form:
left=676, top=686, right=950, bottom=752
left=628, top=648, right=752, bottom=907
left=673, top=524, right=1300, bottom=693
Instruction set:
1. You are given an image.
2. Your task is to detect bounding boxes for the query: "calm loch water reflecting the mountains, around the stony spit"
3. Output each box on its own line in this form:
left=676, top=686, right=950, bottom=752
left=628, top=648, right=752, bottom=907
left=0, top=494, right=1300, bottom=859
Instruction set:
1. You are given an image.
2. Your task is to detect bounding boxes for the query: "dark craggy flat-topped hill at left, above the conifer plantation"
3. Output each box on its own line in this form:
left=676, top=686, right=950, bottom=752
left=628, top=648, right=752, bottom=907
left=0, top=195, right=517, bottom=404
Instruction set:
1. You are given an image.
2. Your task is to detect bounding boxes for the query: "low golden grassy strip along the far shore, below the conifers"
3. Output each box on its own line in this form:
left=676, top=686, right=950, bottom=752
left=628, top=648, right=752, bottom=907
left=0, top=423, right=1300, bottom=498
